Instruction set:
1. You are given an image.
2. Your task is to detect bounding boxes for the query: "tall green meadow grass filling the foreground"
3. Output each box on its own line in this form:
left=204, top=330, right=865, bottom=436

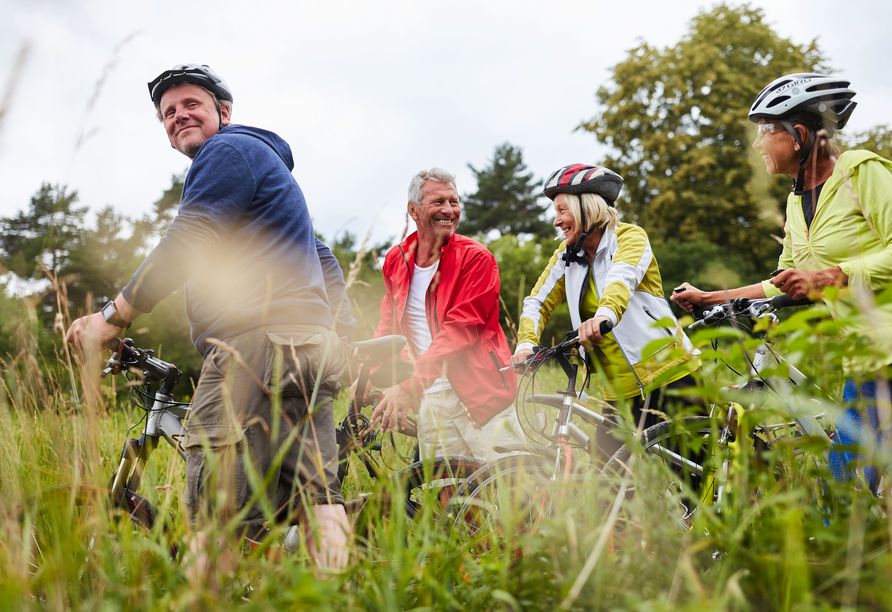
left=0, top=288, right=892, bottom=611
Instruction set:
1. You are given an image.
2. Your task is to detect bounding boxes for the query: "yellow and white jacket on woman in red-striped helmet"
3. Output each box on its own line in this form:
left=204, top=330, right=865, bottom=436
left=517, top=223, right=700, bottom=400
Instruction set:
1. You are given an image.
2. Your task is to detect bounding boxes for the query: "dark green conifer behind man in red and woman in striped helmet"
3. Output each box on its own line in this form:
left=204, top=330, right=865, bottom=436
left=461, top=142, right=554, bottom=237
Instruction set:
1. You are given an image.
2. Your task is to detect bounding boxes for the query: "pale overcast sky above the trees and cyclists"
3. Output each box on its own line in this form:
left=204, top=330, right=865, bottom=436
left=0, top=0, right=892, bottom=250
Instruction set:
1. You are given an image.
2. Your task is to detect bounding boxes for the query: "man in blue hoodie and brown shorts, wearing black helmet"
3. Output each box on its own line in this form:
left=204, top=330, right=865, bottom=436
left=67, top=64, right=355, bottom=573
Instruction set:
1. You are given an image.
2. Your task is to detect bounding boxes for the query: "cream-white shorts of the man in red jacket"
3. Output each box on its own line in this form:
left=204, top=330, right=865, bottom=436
left=417, top=389, right=526, bottom=461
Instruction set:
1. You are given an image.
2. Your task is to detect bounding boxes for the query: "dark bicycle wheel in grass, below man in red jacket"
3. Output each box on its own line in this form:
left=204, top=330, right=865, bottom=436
left=348, top=457, right=484, bottom=548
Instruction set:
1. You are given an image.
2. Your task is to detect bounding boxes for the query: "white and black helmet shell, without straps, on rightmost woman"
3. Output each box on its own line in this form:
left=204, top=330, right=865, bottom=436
left=749, top=72, right=858, bottom=137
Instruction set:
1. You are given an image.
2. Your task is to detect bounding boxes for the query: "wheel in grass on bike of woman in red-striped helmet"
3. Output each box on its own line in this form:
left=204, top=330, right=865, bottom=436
left=442, top=455, right=603, bottom=557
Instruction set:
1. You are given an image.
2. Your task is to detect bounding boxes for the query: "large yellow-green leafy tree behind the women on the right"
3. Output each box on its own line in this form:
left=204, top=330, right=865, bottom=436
left=580, top=4, right=826, bottom=273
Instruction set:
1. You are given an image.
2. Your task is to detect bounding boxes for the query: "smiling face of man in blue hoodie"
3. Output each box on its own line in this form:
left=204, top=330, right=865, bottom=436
left=160, top=83, right=229, bottom=159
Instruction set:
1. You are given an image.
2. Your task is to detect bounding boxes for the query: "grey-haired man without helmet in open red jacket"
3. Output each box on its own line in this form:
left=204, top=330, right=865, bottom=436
left=364, top=168, right=523, bottom=461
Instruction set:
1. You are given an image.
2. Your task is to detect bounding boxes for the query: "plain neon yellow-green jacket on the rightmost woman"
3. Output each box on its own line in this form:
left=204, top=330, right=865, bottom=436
left=762, top=151, right=892, bottom=375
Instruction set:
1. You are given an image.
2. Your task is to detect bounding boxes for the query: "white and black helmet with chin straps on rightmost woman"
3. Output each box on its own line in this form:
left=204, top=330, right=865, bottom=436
left=749, top=72, right=858, bottom=195
